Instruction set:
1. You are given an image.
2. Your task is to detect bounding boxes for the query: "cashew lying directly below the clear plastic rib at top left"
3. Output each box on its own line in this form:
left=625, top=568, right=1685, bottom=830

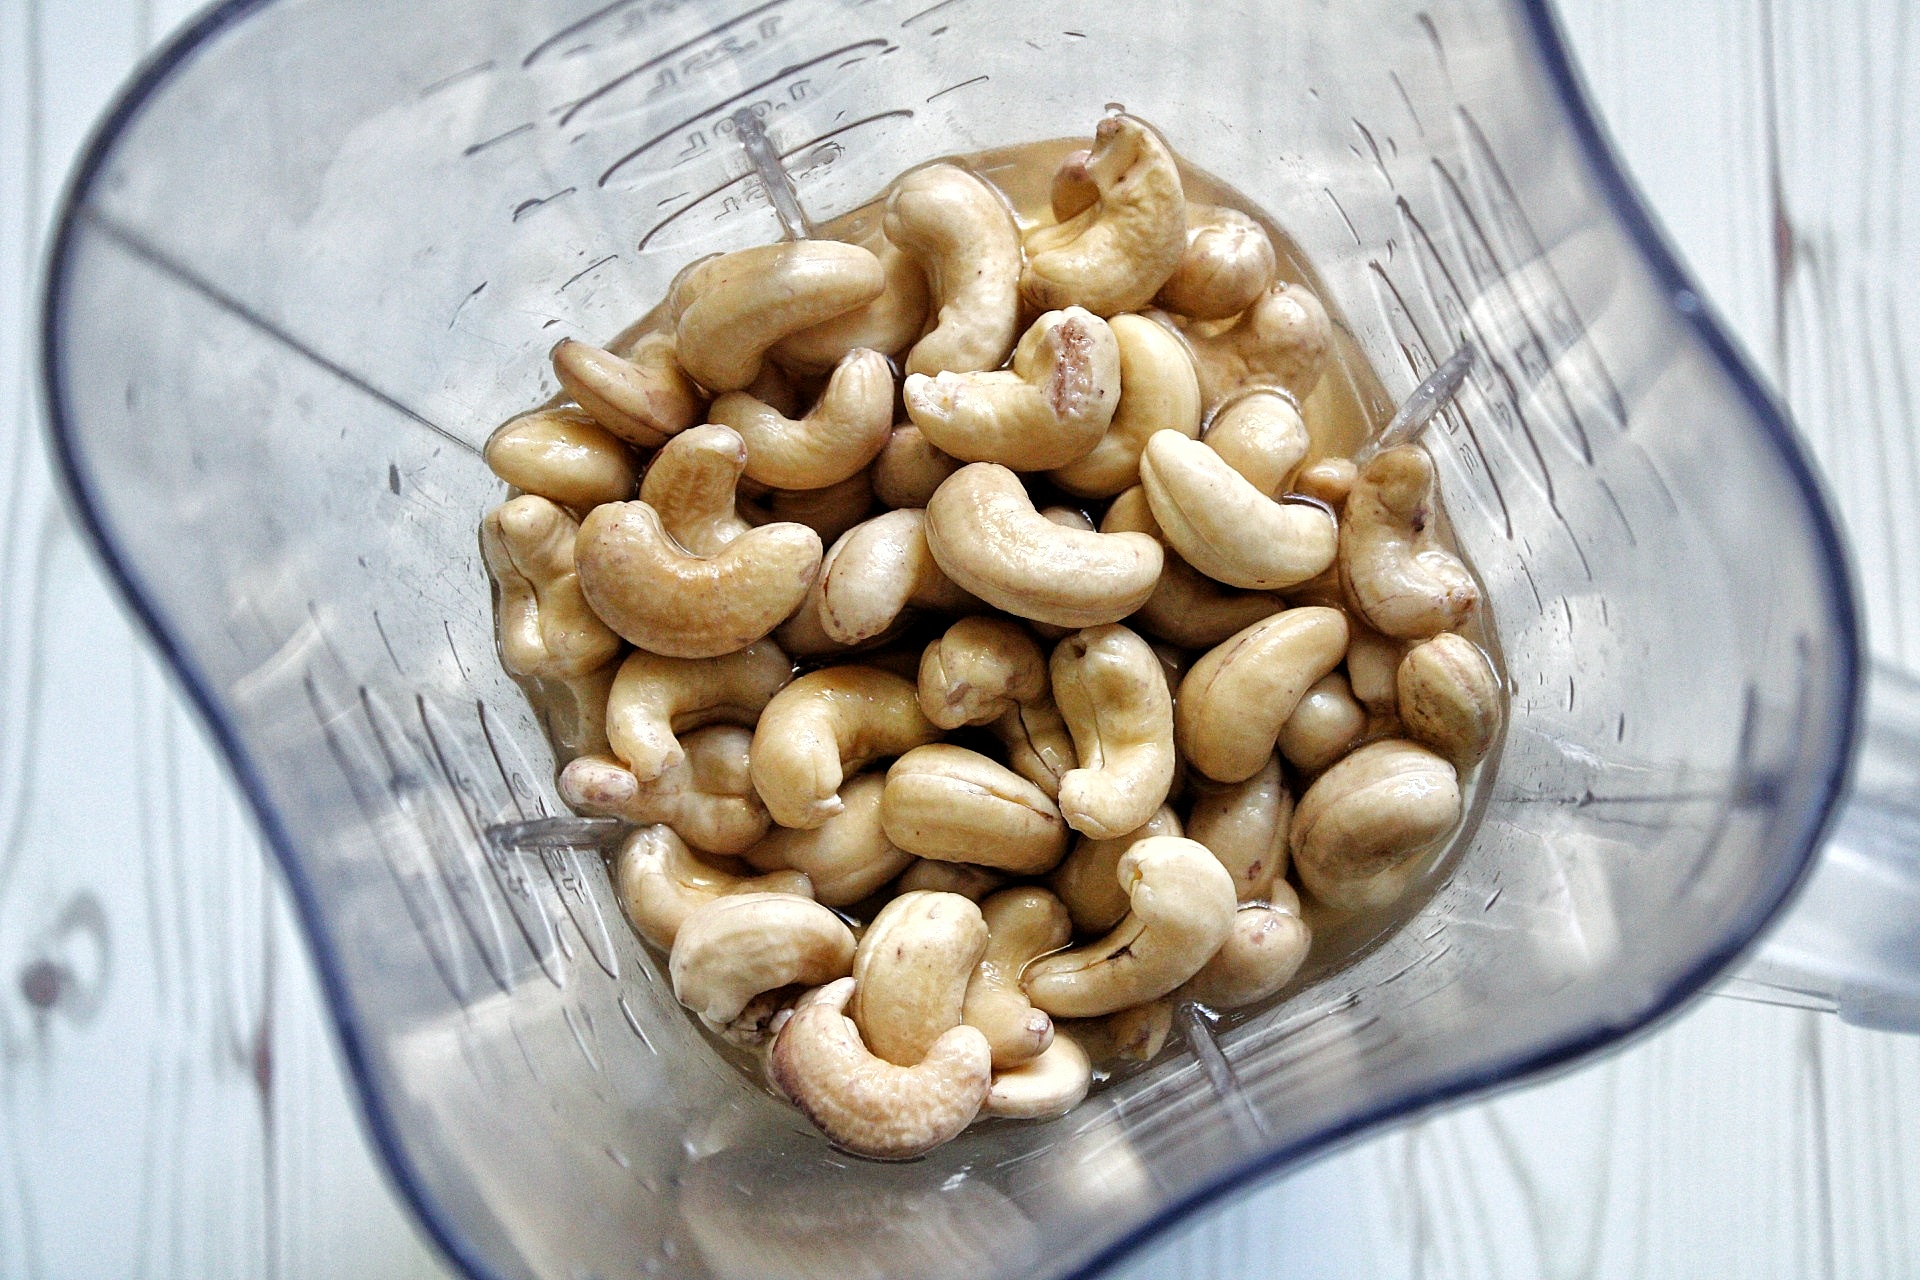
left=668, top=240, right=887, bottom=391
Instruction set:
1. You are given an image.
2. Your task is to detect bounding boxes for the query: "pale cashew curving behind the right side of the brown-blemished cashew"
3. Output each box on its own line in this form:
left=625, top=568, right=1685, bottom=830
left=1052, top=315, right=1200, bottom=497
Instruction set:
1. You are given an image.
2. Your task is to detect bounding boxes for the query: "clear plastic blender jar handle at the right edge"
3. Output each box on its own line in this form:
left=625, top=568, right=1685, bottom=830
left=1722, top=664, right=1920, bottom=1032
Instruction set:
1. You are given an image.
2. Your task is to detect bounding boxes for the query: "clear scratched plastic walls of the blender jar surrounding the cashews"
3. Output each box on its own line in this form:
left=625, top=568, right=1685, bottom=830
left=48, top=0, right=1857, bottom=1280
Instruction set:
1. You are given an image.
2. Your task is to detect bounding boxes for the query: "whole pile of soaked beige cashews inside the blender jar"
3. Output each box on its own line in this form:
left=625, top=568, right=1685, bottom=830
left=482, top=115, right=1503, bottom=1159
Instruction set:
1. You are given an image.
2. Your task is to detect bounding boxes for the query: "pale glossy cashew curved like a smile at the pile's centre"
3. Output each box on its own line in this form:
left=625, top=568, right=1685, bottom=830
left=927, top=462, right=1162, bottom=628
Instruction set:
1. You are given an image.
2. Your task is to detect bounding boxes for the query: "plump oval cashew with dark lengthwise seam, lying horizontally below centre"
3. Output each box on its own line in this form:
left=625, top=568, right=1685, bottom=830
left=879, top=743, right=1069, bottom=875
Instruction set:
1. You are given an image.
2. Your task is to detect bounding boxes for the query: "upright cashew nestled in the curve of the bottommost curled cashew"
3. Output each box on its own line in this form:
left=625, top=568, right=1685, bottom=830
left=847, top=892, right=987, bottom=1067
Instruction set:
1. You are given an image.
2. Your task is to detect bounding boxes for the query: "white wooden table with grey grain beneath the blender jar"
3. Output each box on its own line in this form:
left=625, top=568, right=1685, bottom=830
left=0, top=0, right=1920, bottom=1280
